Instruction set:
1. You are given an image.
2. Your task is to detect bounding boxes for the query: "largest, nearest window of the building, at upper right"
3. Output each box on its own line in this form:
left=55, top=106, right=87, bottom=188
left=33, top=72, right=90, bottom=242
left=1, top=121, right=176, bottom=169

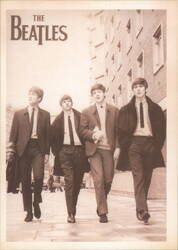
left=153, top=25, right=164, bottom=74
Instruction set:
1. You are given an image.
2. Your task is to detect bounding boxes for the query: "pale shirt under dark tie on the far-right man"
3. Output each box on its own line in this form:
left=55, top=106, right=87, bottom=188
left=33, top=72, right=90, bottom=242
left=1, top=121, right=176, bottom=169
left=134, top=98, right=152, bottom=136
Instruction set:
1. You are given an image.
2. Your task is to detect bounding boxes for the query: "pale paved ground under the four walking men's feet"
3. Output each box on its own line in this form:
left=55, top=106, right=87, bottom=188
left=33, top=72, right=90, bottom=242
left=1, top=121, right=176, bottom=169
left=6, top=189, right=166, bottom=242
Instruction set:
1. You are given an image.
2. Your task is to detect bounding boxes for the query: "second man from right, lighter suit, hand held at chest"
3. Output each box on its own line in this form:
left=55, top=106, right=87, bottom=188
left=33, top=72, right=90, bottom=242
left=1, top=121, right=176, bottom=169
left=80, top=84, right=120, bottom=223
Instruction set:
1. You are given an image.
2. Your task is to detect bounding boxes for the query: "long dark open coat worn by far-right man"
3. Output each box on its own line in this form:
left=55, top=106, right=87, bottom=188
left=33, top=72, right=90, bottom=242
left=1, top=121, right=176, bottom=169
left=117, top=97, right=166, bottom=171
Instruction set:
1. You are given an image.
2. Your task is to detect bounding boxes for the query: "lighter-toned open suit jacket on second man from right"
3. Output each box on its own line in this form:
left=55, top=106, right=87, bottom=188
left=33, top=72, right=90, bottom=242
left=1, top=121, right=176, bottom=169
left=80, top=104, right=119, bottom=156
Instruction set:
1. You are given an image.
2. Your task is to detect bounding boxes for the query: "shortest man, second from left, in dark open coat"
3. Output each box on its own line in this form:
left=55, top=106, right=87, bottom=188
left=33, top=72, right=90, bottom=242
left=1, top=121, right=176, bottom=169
left=51, top=95, right=88, bottom=223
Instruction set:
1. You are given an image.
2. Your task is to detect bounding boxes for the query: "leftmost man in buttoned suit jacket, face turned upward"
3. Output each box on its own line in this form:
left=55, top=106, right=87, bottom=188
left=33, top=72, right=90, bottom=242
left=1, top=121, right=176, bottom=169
left=9, top=87, right=50, bottom=222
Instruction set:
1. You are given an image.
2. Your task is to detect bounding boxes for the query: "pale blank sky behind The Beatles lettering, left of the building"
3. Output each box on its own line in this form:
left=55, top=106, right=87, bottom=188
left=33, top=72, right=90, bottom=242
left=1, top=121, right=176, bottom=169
left=6, top=10, right=90, bottom=115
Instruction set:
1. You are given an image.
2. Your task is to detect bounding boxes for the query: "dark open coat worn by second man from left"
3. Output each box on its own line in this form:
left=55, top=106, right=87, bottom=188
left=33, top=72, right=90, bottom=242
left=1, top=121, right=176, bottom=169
left=50, top=109, right=89, bottom=176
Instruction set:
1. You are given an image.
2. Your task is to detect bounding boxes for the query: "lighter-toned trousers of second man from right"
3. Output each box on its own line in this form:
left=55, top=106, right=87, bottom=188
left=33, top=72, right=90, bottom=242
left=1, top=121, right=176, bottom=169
left=90, top=148, right=114, bottom=215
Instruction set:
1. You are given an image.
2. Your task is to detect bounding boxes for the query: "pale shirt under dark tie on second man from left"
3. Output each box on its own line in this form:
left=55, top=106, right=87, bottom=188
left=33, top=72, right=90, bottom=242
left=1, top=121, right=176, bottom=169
left=64, top=110, right=82, bottom=145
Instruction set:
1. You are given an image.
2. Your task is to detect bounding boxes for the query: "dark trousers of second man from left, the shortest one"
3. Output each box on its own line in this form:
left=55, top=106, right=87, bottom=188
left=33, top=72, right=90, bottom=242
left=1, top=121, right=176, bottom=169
left=59, top=145, right=86, bottom=215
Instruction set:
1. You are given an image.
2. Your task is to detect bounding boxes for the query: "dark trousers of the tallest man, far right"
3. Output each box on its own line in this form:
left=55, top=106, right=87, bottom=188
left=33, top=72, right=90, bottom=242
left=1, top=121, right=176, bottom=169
left=129, top=136, right=156, bottom=212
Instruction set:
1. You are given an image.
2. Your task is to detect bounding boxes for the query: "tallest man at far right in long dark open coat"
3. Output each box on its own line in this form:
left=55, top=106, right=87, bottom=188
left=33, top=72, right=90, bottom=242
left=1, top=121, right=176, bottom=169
left=117, top=78, right=166, bottom=224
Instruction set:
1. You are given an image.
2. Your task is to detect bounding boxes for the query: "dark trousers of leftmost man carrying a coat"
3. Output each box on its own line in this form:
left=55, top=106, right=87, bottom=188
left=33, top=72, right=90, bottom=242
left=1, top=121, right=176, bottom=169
left=19, top=139, right=44, bottom=211
